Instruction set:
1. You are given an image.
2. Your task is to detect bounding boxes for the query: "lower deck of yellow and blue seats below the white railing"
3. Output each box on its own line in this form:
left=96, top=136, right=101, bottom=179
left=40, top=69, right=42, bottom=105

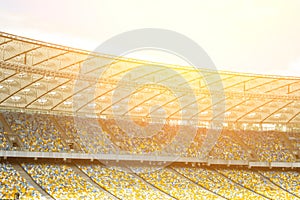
left=0, top=160, right=300, bottom=200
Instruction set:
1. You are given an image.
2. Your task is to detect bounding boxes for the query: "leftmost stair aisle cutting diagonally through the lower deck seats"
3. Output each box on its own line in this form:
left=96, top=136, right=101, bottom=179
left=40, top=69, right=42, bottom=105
left=11, top=162, right=55, bottom=199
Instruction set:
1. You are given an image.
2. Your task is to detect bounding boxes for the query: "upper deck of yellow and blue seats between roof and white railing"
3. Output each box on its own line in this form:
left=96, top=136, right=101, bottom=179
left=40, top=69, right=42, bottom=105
left=0, top=112, right=300, bottom=162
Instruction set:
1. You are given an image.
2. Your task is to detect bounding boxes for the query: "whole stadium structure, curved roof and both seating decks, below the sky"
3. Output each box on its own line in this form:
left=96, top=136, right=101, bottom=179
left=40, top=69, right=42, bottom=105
left=0, top=32, right=300, bottom=199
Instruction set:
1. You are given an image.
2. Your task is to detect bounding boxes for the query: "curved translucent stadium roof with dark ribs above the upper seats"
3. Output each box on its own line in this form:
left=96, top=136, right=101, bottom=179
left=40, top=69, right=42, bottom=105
left=0, top=32, right=300, bottom=124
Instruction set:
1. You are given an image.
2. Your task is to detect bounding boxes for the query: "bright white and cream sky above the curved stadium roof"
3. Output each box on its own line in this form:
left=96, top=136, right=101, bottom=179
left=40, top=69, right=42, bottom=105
left=0, top=0, right=300, bottom=76
